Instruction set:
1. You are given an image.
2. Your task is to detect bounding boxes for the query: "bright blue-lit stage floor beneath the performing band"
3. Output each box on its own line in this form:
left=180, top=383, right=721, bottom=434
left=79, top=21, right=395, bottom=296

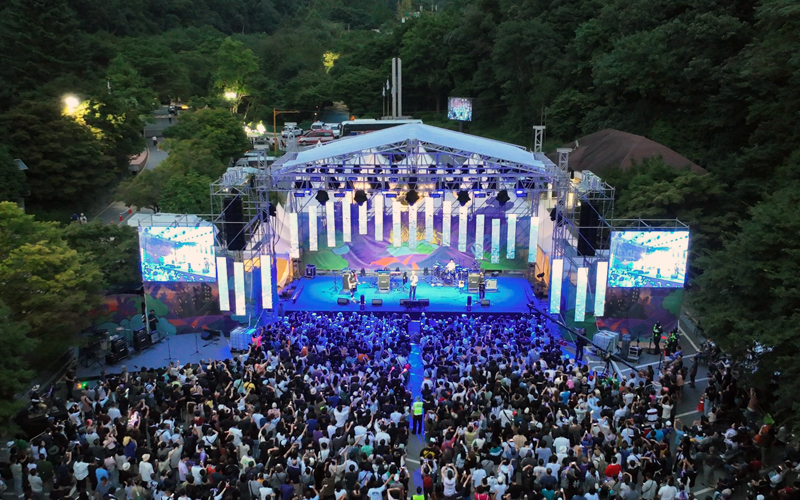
left=281, top=275, right=534, bottom=314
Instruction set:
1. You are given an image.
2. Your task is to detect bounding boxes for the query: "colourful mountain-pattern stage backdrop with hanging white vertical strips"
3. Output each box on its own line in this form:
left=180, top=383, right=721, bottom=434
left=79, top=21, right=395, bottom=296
left=288, top=196, right=537, bottom=270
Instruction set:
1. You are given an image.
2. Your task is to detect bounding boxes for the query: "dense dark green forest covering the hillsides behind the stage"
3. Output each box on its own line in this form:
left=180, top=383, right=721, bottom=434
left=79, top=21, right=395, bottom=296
left=0, top=0, right=800, bottom=424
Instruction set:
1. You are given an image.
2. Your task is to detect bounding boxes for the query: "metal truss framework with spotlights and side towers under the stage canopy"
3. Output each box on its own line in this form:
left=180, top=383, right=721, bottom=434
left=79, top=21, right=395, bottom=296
left=206, top=124, right=614, bottom=316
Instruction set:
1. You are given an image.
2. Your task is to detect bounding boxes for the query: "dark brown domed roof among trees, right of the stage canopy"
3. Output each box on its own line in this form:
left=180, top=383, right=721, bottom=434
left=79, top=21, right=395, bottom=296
left=552, top=128, right=707, bottom=177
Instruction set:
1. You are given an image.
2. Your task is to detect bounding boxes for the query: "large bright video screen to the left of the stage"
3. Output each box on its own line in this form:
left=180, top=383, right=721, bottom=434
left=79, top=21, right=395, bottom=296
left=139, top=226, right=217, bottom=283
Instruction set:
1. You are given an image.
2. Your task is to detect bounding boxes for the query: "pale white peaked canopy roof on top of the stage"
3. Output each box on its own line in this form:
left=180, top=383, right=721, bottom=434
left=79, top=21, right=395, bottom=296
left=280, top=124, right=549, bottom=172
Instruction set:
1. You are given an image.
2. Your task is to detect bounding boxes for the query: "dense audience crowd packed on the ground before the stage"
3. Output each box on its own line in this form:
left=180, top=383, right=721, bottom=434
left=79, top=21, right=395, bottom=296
left=2, top=312, right=800, bottom=500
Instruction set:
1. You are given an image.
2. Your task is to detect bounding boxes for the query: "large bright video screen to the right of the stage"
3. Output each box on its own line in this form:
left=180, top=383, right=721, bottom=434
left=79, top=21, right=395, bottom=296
left=608, top=231, right=689, bottom=288
